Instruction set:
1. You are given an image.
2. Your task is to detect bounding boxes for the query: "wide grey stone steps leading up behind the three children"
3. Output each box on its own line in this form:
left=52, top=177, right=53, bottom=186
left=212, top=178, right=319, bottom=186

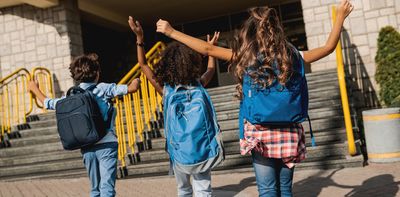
left=0, top=70, right=363, bottom=181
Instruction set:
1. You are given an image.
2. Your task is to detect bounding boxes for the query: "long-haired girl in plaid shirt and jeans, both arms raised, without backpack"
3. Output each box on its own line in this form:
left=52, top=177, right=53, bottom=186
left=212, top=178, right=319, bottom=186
left=157, top=0, right=353, bottom=196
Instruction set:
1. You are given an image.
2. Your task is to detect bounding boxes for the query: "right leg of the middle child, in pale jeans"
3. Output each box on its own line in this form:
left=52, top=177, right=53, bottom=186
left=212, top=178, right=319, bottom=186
left=193, top=170, right=212, bottom=197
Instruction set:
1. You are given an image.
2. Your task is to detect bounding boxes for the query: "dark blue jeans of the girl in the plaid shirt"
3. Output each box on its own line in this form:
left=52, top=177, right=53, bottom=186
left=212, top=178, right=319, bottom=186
left=252, top=151, right=294, bottom=197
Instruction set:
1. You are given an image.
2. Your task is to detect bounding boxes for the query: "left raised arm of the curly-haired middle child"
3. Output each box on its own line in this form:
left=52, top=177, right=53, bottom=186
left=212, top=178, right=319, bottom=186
left=128, top=16, right=163, bottom=95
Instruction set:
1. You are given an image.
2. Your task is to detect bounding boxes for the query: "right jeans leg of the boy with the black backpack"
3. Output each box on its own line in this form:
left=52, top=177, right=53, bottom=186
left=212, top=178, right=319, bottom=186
left=96, top=143, right=118, bottom=197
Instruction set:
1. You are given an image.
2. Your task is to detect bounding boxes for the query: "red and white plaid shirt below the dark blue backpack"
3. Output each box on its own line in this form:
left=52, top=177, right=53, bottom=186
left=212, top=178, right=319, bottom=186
left=240, top=122, right=306, bottom=168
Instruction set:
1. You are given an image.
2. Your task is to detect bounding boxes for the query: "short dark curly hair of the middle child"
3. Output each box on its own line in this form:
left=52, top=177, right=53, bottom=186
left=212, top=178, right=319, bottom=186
left=154, top=41, right=202, bottom=86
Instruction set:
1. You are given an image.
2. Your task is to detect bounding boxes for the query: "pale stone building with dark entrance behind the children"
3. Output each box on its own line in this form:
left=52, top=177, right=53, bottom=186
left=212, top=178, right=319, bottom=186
left=0, top=0, right=400, bottom=101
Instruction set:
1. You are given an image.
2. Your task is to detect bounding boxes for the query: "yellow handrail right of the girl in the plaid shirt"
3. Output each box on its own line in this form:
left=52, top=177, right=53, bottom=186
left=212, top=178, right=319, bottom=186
left=332, top=6, right=356, bottom=156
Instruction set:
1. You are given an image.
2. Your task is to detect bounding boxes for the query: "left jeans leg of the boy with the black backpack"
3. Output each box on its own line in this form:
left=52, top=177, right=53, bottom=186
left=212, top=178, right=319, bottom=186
left=82, top=149, right=100, bottom=197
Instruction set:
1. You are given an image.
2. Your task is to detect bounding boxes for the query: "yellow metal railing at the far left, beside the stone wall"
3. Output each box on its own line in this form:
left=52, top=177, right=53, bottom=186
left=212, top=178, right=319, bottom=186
left=0, top=67, right=54, bottom=145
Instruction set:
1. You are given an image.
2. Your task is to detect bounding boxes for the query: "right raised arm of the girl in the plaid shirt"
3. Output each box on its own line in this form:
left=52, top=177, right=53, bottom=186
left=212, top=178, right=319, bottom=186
left=304, top=0, right=353, bottom=63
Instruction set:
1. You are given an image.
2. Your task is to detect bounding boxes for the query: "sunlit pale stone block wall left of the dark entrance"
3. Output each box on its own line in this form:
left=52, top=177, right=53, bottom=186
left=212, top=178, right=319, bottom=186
left=0, top=0, right=83, bottom=96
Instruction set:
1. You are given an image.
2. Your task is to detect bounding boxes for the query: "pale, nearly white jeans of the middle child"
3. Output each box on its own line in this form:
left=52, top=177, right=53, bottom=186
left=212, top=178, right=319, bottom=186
left=174, top=165, right=212, bottom=197
